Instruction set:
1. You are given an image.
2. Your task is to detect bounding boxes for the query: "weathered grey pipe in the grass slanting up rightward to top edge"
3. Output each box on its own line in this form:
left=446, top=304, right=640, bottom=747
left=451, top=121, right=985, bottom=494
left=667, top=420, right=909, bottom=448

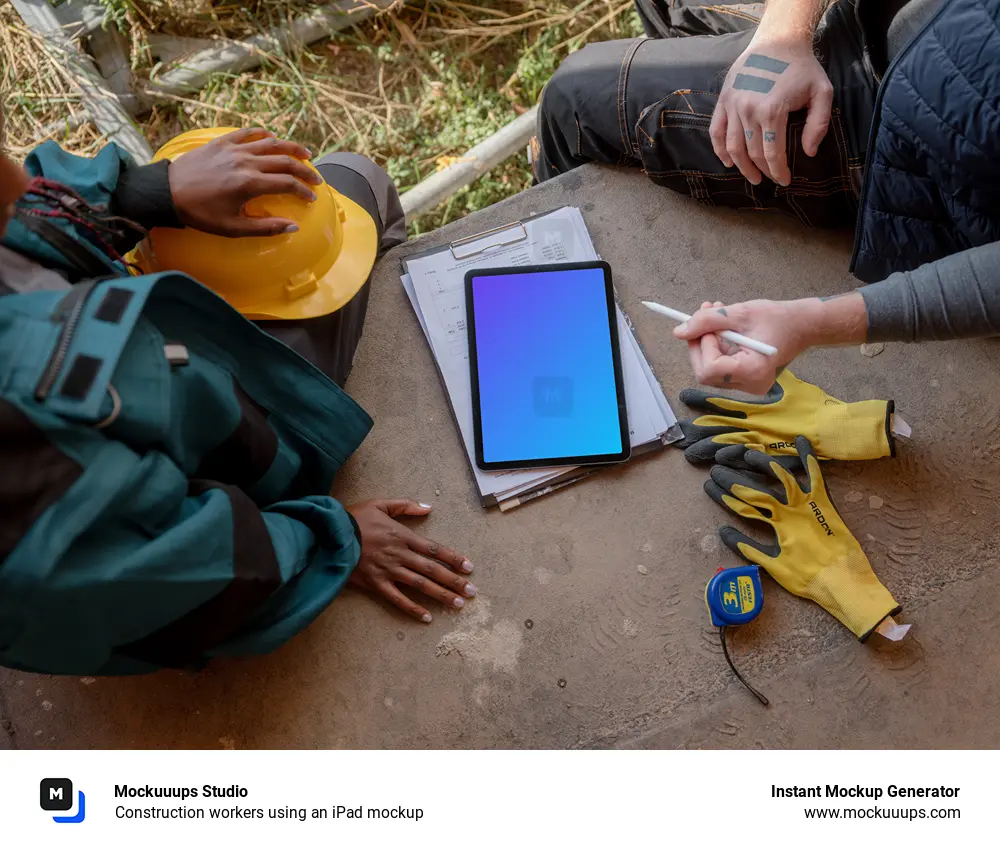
left=149, top=0, right=394, bottom=94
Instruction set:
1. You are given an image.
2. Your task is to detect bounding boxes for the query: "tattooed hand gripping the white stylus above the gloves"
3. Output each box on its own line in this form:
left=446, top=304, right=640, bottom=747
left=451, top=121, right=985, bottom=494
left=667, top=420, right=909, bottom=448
left=674, top=300, right=808, bottom=394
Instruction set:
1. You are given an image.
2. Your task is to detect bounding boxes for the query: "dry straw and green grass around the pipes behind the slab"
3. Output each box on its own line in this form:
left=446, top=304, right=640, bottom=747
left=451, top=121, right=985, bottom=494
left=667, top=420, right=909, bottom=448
left=0, top=0, right=639, bottom=232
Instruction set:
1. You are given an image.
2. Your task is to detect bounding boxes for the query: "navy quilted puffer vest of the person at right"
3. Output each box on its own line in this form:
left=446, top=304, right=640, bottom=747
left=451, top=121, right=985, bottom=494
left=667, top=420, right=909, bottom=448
left=851, top=0, right=1000, bottom=281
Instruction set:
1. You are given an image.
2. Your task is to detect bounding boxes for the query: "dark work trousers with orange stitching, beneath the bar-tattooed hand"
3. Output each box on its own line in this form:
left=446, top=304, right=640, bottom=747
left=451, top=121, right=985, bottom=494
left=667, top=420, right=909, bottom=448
left=532, top=0, right=876, bottom=227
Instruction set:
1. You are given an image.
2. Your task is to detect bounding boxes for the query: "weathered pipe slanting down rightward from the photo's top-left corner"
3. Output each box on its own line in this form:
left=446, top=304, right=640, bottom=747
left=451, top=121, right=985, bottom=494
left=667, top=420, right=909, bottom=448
left=11, top=0, right=153, bottom=163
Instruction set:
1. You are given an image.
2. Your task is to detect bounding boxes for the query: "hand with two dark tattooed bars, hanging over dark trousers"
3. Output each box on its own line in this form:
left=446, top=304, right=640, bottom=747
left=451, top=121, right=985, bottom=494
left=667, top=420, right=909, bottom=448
left=709, top=38, right=833, bottom=186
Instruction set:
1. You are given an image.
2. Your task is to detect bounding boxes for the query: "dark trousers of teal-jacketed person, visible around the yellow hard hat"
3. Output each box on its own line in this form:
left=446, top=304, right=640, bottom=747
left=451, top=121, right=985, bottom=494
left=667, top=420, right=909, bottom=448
left=258, top=153, right=406, bottom=386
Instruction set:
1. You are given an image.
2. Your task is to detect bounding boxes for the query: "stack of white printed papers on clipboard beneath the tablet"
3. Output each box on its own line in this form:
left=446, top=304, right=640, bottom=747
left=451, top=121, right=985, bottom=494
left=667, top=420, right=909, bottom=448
left=401, top=207, right=681, bottom=509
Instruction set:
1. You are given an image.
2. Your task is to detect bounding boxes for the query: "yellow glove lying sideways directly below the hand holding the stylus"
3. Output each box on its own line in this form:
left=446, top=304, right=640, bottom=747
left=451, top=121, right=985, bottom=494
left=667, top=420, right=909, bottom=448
left=677, top=369, right=896, bottom=463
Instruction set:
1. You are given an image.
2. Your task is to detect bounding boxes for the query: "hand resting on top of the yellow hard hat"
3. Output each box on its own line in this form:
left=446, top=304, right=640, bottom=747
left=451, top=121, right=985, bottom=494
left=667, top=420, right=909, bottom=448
left=167, top=129, right=323, bottom=237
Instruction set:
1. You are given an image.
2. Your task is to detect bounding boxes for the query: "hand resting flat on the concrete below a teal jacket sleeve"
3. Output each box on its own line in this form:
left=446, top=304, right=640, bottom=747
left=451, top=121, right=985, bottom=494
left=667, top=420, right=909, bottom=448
left=347, top=499, right=476, bottom=623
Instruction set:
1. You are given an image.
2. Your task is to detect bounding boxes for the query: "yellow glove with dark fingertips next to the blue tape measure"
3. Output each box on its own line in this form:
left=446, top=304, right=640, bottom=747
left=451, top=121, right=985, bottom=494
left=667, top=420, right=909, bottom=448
left=705, top=437, right=900, bottom=640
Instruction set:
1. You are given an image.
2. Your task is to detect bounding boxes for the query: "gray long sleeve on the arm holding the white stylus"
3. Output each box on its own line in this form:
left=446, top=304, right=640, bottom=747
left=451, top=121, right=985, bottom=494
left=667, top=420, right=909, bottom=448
left=858, top=242, right=1000, bottom=342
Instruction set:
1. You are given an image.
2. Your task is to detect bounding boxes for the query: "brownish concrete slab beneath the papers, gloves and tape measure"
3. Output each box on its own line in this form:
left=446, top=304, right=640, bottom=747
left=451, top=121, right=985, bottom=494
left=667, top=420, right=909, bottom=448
left=0, top=162, right=1000, bottom=748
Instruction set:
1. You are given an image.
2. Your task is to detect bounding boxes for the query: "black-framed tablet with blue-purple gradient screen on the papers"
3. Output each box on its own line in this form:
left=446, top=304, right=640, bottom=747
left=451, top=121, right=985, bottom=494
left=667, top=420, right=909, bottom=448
left=465, top=262, right=631, bottom=470
